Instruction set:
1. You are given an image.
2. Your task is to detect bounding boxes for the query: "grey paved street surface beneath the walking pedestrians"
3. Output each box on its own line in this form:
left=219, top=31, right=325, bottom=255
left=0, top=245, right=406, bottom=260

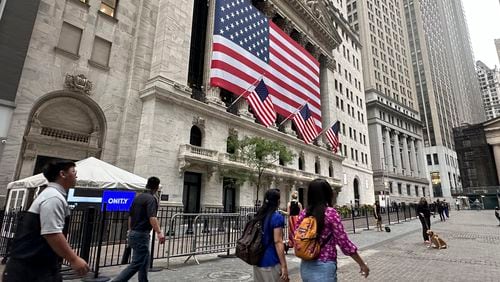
left=64, top=210, right=500, bottom=281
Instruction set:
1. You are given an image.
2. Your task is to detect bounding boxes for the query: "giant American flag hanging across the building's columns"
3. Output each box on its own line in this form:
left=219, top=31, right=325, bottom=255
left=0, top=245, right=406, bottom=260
left=210, top=0, right=321, bottom=135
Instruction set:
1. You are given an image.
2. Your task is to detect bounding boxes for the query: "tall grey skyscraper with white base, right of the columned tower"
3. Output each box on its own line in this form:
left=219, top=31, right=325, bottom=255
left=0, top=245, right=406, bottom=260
left=404, top=0, right=464, bottom=197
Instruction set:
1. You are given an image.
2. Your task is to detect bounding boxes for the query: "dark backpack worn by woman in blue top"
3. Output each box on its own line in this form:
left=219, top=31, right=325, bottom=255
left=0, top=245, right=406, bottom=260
left=236, top=219, right=266, bottom=265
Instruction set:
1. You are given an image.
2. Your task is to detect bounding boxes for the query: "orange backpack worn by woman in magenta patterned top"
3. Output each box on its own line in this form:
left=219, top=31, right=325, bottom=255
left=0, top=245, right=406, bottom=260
left=293, top=216, right=321, bottom=260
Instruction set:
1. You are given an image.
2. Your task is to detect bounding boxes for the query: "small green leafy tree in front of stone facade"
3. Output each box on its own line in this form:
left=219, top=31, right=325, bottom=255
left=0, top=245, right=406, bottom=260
left=225, top=136, right=295, bottom=204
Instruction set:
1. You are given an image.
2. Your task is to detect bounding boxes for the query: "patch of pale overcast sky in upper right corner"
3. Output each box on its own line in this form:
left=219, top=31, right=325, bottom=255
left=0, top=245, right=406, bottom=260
left=462, top=0, right=500, bottom=68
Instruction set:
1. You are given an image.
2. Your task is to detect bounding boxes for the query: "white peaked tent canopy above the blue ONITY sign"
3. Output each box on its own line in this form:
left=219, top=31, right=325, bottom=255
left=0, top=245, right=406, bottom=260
left=7, top=157, right=147, bottom=190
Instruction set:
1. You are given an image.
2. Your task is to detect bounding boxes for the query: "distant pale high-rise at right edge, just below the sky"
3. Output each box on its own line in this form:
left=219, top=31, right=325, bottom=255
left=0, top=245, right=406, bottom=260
left=476, top=61, right=500, bottom=119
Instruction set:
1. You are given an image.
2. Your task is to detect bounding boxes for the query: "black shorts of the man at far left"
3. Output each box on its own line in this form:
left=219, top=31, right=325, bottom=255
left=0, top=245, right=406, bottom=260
left=2, top=258, right=62, bottom=282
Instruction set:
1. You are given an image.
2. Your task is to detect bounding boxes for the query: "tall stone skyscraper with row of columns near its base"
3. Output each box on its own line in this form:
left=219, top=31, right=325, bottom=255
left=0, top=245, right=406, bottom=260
left=347, top=0, right=429, bottom=201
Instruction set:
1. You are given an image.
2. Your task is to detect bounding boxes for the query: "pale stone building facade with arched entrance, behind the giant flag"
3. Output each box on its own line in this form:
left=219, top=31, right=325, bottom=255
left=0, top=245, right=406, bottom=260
left=0, top=0, right=373, bottom=212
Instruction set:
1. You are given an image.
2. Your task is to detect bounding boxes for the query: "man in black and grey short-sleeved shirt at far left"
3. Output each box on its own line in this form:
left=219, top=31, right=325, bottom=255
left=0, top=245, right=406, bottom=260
left=2, top=161, right=89, bottom=282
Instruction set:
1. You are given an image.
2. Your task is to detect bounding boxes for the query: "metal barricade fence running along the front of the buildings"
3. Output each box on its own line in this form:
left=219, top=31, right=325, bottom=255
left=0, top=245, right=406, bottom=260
left=0, top=205, right=416, bottom=277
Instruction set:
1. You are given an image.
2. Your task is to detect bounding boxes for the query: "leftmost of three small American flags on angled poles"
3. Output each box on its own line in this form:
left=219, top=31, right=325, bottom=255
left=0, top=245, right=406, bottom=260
left=245, top=79, right=276, bottom=127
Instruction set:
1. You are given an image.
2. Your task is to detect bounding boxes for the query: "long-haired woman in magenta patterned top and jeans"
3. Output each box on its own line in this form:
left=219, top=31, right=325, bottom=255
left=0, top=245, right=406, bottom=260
left=297, top=179, right=370, bottom=282
